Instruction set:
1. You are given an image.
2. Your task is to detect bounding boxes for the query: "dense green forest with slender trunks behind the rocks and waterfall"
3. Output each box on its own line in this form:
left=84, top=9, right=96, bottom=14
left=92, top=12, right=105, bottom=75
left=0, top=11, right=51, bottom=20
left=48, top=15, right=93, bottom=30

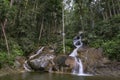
left=0, top=0, right=120, bottom=67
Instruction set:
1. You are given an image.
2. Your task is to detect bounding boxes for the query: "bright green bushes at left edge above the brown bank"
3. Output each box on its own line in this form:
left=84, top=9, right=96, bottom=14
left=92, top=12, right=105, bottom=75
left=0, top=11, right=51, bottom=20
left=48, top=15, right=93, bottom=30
left=0, top=41, right=23, bottom=67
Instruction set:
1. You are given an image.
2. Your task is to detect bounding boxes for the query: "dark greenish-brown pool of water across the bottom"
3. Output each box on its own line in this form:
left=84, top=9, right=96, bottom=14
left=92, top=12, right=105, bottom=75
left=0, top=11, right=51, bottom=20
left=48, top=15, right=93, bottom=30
left=0, top=72, right=120, bottom=80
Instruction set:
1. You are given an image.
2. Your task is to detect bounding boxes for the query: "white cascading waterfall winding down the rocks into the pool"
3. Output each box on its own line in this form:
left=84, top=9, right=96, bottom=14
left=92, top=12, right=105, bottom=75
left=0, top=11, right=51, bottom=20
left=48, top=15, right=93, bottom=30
left=69, top=33, right=84, bottom=75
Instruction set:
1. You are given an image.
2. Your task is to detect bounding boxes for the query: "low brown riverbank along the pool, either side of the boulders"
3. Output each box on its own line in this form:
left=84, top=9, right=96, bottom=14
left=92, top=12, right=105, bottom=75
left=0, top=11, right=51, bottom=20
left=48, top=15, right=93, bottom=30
left=0, top=62, right=120, bottom=77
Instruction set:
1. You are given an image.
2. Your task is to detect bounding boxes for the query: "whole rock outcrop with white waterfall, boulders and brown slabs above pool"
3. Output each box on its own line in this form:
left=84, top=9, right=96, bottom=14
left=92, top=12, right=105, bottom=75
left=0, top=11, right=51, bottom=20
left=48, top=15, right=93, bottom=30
left=24, top=33, right=109, bottom=76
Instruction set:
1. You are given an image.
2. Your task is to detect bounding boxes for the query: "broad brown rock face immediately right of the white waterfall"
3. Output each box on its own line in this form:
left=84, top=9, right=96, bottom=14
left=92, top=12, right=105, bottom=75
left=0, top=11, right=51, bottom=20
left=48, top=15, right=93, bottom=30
left=78, top=47, right=109, bottom=74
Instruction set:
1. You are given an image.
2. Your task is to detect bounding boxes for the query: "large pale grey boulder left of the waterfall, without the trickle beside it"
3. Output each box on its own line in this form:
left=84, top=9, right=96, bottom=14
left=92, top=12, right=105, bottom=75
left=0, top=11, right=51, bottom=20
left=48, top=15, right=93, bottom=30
left=28, top=54, right=55, bottom=71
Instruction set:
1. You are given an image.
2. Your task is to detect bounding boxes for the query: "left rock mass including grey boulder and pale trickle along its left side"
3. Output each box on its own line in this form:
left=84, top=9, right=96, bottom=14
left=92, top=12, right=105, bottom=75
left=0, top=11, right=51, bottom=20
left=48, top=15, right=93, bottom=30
left=24, top=47, right=55, bottom=71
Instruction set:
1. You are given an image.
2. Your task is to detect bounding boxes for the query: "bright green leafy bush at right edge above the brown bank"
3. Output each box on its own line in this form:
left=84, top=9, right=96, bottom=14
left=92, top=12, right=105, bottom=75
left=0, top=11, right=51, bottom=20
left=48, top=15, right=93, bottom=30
left=102, top=39, right=120, bottom=61
